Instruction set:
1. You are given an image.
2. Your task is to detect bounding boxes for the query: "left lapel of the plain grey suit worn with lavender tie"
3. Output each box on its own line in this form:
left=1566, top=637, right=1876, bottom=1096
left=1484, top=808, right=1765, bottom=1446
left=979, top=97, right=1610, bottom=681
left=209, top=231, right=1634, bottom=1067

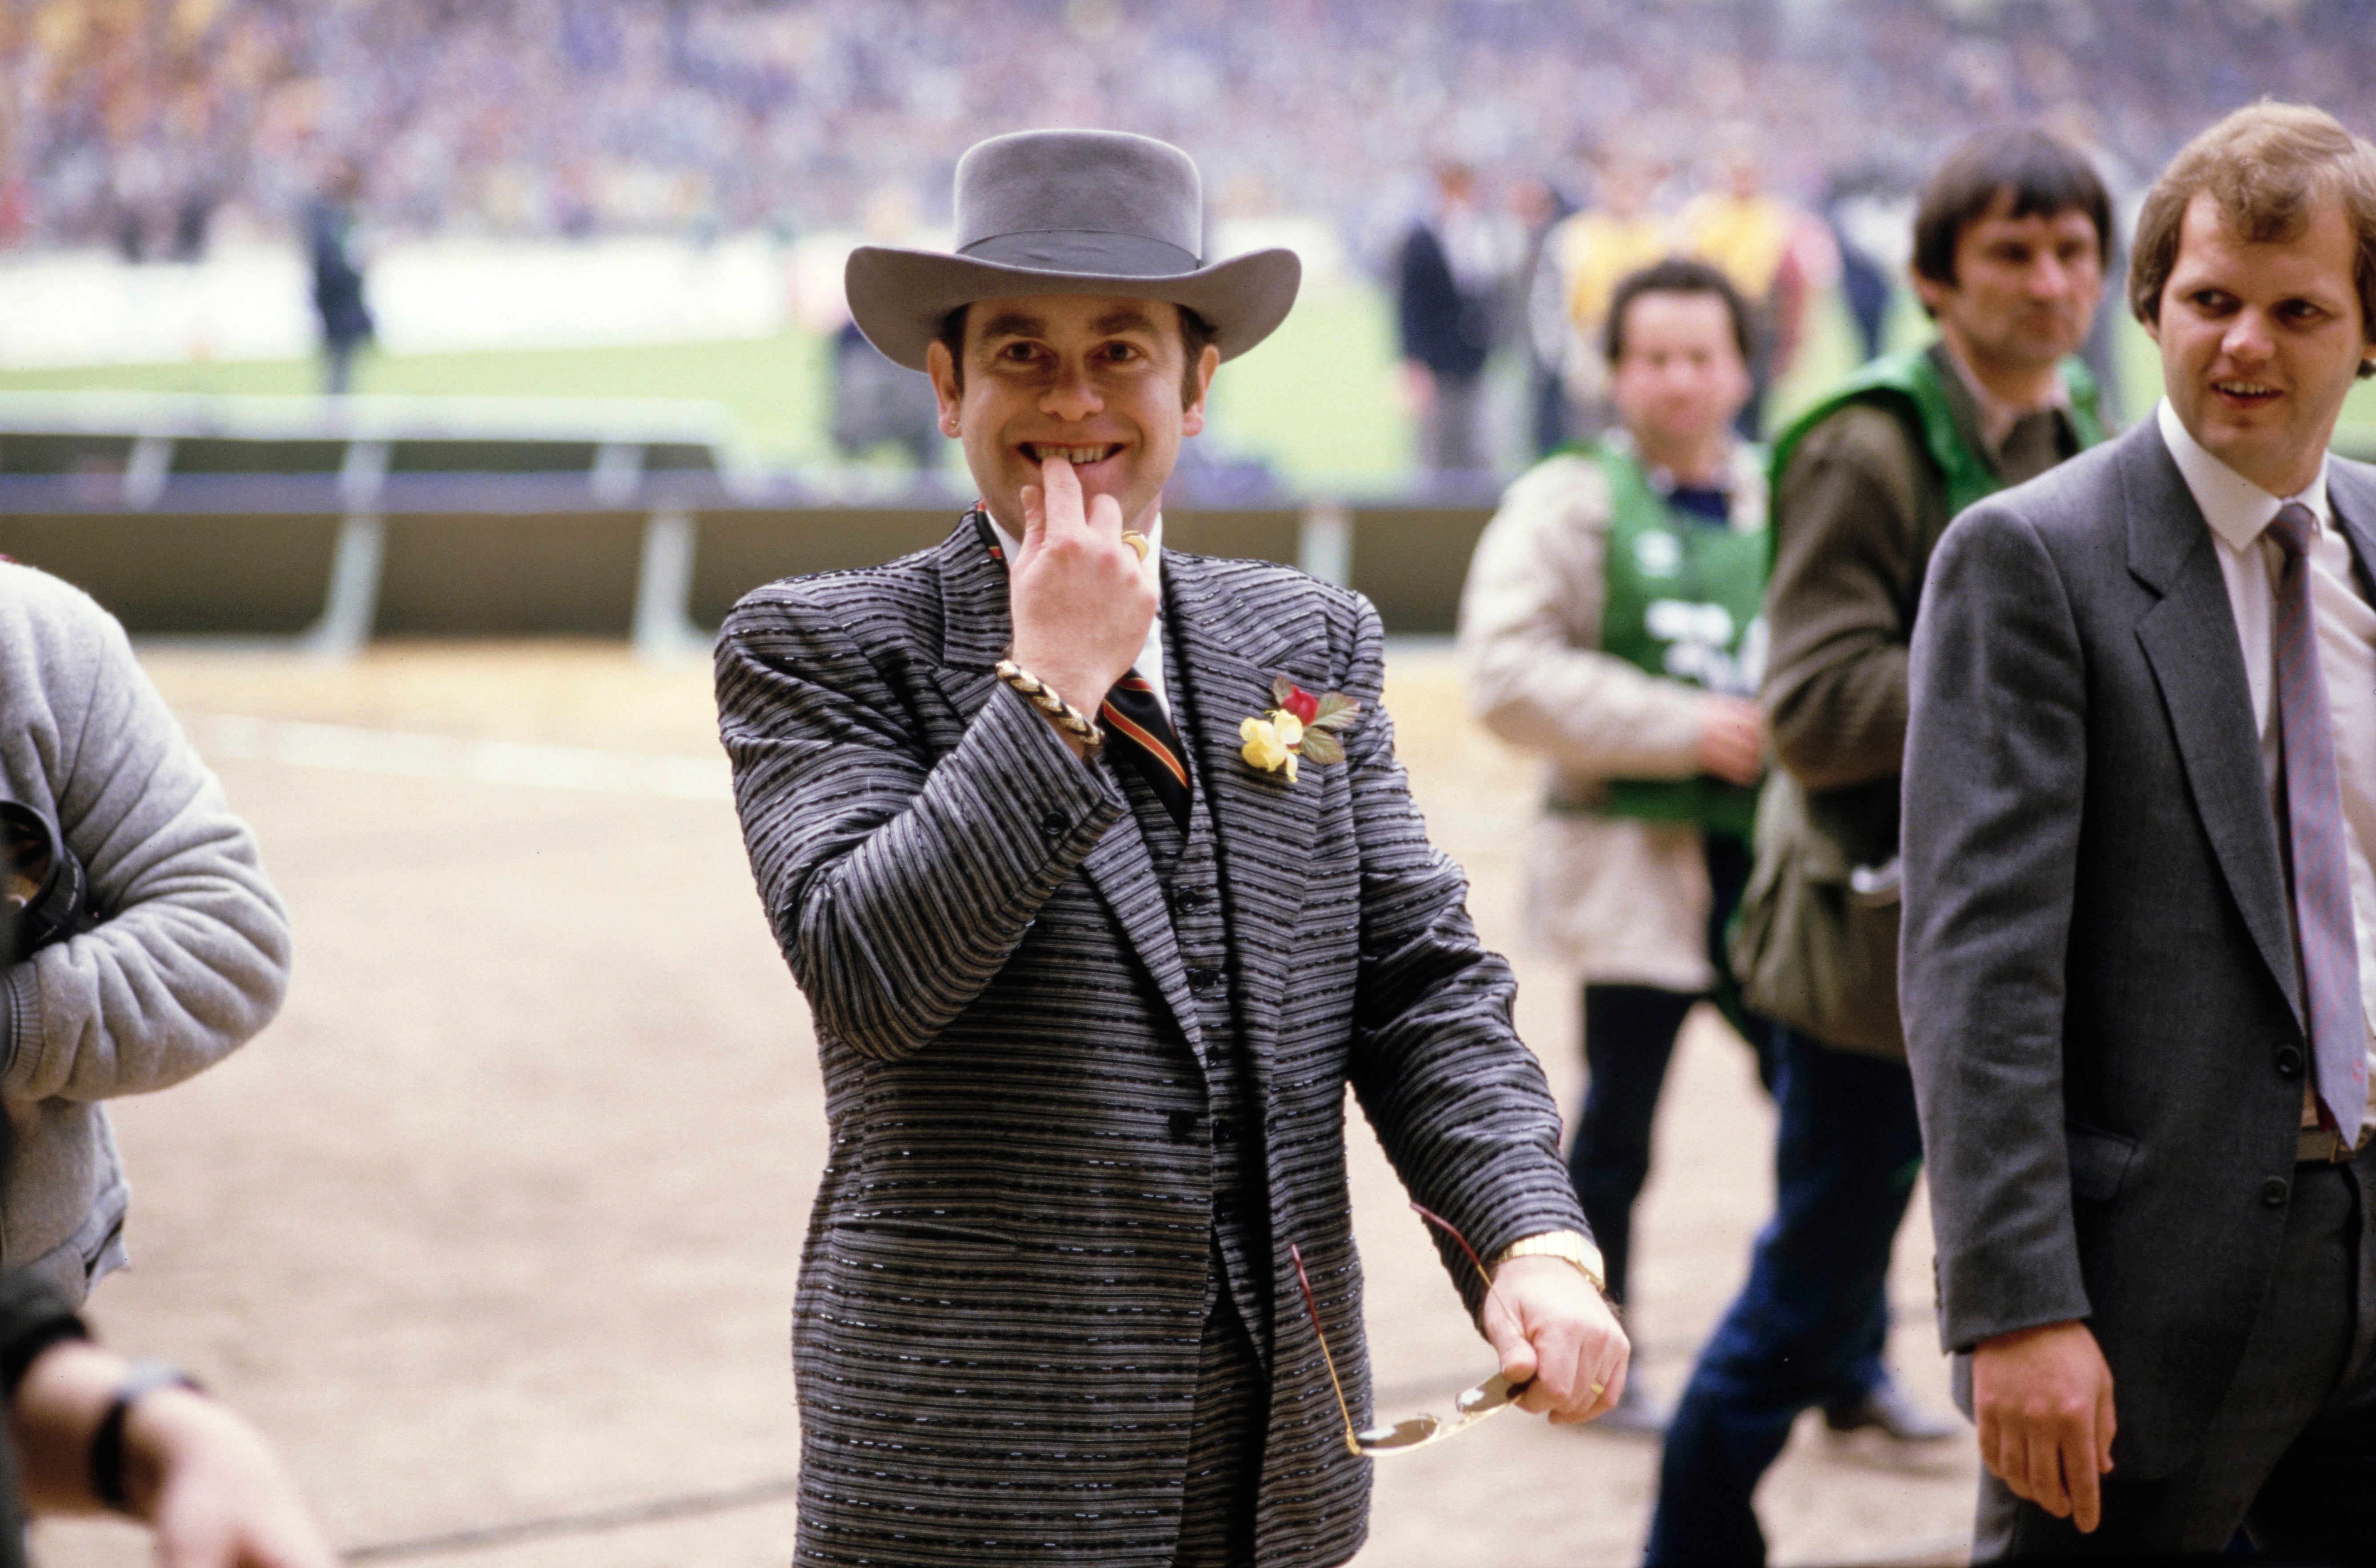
left=2119, top=418, right=2302, bottom=1017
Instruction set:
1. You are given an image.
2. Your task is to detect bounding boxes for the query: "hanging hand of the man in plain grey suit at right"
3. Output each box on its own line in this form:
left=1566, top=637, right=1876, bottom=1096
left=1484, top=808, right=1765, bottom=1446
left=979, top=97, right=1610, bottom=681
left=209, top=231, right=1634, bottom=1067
left=1972, top=1321, right=2117, bottom=1530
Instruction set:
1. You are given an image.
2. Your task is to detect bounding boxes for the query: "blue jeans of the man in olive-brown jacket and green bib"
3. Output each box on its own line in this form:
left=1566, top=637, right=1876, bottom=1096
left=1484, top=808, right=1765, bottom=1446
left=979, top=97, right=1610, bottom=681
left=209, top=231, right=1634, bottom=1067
left=1644, top=1027, right=1922, bottom=1568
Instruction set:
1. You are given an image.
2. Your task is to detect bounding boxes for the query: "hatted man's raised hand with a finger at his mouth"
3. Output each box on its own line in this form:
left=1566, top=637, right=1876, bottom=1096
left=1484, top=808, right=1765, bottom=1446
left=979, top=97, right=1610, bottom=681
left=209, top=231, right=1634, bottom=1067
left=1007, top=458, right=1155, bottom=751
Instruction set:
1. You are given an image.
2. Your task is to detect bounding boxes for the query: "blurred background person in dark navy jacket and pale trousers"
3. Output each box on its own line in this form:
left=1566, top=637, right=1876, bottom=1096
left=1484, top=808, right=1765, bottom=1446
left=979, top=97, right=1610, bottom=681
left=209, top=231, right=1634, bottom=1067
left=1395, top=164, right=1516, bottom=473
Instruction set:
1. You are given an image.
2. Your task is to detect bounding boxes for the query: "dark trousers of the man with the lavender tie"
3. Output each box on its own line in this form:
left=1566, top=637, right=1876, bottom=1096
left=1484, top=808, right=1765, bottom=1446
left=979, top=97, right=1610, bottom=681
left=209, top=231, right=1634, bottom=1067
left=1972, top=1164, right=2376, bottom=1566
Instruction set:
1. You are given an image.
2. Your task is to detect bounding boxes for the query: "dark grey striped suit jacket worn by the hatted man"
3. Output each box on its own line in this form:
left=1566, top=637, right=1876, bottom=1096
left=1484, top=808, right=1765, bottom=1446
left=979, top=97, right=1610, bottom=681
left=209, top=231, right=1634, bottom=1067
left=718, top=525, right=1582, bottom=1568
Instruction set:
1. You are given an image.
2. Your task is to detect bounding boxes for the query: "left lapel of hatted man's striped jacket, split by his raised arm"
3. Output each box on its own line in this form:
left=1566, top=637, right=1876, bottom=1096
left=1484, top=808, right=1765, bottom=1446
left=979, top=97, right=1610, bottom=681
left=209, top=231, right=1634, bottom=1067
left=931, top=518, right=1202, bottom=1045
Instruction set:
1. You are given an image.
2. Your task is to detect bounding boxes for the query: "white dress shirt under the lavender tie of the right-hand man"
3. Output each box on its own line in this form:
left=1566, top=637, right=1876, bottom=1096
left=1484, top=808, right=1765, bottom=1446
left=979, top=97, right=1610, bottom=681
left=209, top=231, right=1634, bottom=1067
left=2155, top=399, right=2376, bottom=1124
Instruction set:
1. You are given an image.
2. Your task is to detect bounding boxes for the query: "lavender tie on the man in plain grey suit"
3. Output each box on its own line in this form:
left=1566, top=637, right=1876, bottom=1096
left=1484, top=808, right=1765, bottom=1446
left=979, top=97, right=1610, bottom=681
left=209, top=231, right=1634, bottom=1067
left=2269, top=501, right=2369, bottom=1143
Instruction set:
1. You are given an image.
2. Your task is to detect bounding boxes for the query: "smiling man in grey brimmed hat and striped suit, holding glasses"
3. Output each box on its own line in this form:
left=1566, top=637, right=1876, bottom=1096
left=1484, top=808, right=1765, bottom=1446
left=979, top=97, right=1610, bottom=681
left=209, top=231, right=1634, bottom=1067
left=718, top=131, right=1628, bottom=1568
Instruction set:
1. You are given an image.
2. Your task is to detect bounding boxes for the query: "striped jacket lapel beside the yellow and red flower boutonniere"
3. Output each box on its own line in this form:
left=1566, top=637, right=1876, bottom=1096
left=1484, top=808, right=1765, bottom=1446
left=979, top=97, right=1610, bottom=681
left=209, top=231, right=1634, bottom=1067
left=1164, top=553, right=1321, bottom=1083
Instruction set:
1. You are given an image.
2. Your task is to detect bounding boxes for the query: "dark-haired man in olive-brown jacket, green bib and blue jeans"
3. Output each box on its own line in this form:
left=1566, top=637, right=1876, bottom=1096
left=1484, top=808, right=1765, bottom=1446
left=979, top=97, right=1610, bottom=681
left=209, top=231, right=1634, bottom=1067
left=1647, top=131, right=2110, bottom=1568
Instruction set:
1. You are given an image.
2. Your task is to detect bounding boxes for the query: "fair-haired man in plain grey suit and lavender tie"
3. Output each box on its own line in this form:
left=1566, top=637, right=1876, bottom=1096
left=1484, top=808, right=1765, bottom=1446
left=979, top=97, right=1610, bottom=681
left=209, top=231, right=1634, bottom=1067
left=1901, top=104, right=2376, bottom=1563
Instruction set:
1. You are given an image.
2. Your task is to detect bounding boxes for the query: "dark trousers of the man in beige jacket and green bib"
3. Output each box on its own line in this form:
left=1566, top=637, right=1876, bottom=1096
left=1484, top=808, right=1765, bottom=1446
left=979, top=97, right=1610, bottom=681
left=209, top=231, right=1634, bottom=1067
left=1568, top=834, right=1770, bottom=1302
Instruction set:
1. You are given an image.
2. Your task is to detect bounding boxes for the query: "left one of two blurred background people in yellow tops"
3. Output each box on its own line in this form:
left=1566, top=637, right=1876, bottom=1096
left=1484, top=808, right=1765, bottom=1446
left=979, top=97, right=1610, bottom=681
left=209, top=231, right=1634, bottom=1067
left=1528, top=152, right=1675, bottom=440
